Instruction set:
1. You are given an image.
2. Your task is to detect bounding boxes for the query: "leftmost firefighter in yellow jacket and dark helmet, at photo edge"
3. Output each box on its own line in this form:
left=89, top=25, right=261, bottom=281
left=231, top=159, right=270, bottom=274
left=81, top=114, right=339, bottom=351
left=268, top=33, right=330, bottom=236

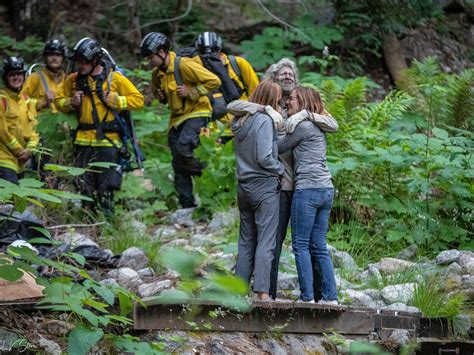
left=0, top=57, right=39, bottom=184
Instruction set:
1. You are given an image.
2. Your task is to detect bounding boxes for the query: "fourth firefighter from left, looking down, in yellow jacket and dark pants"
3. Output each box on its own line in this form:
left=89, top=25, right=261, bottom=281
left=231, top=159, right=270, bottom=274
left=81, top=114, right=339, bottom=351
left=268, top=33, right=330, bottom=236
left=140, top=32, right=221, bottom=208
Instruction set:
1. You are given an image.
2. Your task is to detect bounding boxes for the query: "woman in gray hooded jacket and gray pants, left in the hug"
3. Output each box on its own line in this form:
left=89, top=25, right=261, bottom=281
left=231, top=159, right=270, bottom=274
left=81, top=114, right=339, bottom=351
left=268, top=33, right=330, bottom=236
left=232, top=80, right=284, bottom=300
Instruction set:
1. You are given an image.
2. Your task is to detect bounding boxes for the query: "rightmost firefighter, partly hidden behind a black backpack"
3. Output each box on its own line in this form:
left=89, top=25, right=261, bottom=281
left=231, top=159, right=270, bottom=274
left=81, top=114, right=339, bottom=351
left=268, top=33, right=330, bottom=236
left=195, top=32, right=259, bottom=143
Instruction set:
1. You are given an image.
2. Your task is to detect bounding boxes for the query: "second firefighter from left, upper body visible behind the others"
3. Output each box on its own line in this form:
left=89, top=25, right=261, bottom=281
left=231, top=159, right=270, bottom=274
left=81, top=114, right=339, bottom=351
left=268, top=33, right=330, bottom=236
left=22, top=39, right=66, bottom=112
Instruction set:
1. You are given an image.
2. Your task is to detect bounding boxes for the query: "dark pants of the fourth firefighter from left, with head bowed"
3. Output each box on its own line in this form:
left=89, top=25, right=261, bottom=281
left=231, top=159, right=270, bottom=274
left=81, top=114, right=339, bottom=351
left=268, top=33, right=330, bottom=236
left=168, top=117, right=207, bottom=208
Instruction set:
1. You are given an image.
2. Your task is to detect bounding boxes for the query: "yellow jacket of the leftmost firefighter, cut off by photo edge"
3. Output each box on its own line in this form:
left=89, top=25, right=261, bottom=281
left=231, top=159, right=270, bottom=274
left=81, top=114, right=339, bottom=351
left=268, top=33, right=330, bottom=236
left=0, top=89, right=39, bottom=173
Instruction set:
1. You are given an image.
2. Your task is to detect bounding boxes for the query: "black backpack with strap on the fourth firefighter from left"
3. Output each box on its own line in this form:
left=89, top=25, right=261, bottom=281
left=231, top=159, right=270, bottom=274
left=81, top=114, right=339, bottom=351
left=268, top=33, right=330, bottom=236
left=174, top=47, right=243, bottom=121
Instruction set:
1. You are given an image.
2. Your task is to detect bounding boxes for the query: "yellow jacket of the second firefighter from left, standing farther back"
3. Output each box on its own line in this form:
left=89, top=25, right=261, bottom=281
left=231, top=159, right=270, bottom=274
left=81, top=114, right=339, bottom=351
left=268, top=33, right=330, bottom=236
left=21, top=68, right=66, bottom=112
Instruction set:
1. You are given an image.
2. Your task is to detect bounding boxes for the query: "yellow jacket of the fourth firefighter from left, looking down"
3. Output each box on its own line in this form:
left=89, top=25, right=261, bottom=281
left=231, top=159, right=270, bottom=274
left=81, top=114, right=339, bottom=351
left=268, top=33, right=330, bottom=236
left=151, top=52, right=221, bottom=128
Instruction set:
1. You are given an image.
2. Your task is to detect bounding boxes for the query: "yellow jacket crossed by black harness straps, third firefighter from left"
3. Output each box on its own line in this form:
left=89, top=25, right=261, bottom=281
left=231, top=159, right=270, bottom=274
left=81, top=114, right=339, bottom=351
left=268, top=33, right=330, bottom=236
left=54, top=71, right=144, bottom=147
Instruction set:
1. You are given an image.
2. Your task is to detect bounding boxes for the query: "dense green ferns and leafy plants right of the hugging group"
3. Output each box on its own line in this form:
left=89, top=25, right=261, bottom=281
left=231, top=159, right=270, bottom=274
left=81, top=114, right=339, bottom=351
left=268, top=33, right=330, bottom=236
left=308, top=60, right=474, bottom=260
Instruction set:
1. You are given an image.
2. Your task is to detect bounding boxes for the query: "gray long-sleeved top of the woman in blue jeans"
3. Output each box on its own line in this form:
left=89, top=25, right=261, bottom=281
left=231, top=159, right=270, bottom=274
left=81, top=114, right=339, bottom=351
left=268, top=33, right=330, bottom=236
left=277, top=121, right=333, bottom=190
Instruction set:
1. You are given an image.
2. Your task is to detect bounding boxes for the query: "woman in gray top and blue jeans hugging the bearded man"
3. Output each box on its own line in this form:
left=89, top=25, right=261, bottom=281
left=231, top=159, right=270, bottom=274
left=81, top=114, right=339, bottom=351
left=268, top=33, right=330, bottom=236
left=278, top=87, right=337, bottom=304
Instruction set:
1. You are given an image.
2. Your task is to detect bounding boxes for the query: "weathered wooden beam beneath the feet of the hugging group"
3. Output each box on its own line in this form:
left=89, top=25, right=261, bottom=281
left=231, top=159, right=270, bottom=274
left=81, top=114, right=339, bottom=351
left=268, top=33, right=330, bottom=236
left=134, top=302, right=374, bottom=335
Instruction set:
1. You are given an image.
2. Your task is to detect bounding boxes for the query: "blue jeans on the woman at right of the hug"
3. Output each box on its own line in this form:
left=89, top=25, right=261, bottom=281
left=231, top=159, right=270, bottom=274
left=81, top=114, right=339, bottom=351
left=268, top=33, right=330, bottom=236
left=291, top=188, right=337, bottom=301
